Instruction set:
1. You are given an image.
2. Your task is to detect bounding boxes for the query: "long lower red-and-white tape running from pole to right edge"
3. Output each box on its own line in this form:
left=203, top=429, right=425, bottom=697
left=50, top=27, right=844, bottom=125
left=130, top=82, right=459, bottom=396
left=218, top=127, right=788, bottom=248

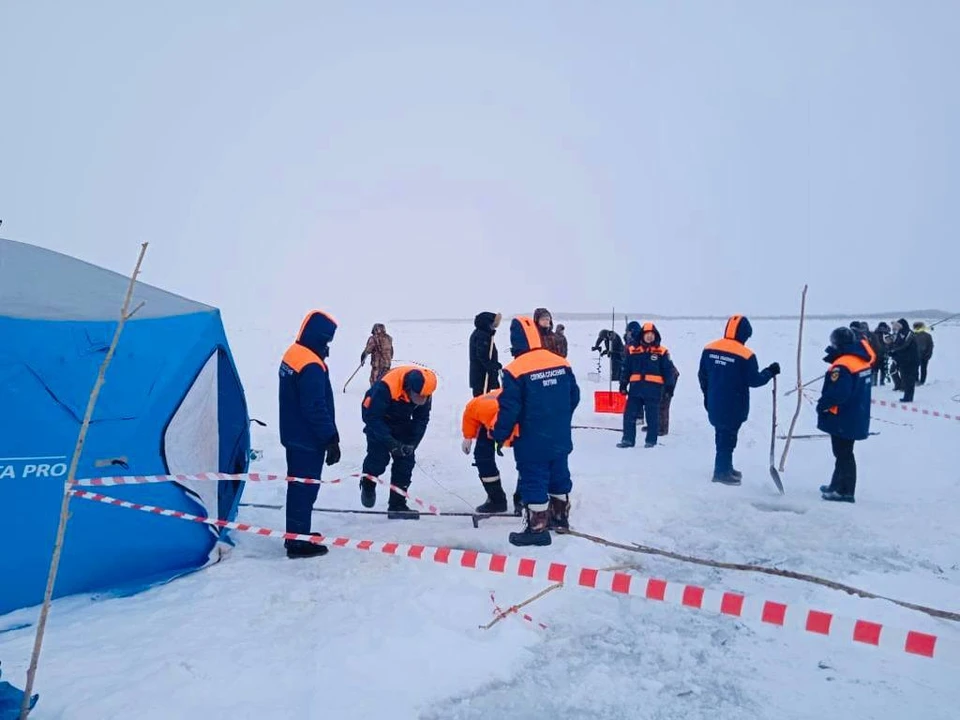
left=69, top=490, right=960, bottom=664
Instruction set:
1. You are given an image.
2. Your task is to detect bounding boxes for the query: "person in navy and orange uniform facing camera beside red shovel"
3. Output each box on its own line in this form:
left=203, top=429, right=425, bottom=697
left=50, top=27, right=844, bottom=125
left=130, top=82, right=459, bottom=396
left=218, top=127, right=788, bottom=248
left=617, top=321, right=675, bottom=448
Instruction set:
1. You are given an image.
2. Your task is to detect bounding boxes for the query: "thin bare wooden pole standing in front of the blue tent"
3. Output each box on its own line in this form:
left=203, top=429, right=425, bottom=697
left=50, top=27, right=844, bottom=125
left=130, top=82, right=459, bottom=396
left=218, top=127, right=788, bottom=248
left=20, top=243, right=147, bottom=720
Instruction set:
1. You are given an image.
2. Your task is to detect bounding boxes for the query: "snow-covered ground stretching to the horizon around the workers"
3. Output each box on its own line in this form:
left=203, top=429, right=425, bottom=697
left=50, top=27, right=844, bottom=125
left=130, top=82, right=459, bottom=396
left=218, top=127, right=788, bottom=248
left=0, top=318, right=960, bottom=720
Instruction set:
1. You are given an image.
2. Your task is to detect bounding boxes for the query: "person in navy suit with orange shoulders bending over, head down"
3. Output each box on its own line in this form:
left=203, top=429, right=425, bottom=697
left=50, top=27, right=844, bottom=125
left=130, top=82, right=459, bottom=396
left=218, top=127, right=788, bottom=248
left=360, top=365, right=437, bottom=520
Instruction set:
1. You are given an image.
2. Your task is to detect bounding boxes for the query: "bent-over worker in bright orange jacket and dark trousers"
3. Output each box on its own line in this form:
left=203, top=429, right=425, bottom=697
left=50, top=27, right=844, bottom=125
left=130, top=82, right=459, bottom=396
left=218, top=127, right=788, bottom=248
left=460, top=388, right=520, bottom=515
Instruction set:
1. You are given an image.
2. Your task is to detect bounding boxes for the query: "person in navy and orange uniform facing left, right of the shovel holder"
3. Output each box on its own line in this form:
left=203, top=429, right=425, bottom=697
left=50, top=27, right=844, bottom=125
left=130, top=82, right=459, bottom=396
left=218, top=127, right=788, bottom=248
left=817, top=327, right=875, bottom=503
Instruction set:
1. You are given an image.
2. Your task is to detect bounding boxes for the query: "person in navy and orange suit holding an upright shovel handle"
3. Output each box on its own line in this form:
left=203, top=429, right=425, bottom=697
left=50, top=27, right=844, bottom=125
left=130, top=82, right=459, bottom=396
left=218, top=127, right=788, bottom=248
left=697, top=315, right=780, bottom=485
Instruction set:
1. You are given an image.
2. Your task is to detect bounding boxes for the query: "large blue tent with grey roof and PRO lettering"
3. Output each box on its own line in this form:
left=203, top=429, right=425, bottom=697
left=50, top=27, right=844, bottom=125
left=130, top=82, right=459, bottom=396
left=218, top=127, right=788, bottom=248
left=0, top=238, right=250, bottom=615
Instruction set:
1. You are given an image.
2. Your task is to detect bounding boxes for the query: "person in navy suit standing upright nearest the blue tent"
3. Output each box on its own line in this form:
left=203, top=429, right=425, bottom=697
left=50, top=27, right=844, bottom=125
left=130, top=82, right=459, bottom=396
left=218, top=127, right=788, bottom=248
left=279, top=310, right=340, bottom=558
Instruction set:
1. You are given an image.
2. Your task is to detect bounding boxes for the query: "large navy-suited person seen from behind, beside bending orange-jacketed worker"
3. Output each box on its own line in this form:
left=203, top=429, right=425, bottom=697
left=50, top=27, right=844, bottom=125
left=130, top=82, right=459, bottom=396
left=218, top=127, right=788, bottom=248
left=492, top=317, right=580, bottom=546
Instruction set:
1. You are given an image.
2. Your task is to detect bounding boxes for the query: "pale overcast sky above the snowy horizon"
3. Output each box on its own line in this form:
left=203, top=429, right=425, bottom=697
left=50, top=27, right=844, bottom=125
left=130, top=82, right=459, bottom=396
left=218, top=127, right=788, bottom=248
left=0, top=0, right=960, bottom=326
